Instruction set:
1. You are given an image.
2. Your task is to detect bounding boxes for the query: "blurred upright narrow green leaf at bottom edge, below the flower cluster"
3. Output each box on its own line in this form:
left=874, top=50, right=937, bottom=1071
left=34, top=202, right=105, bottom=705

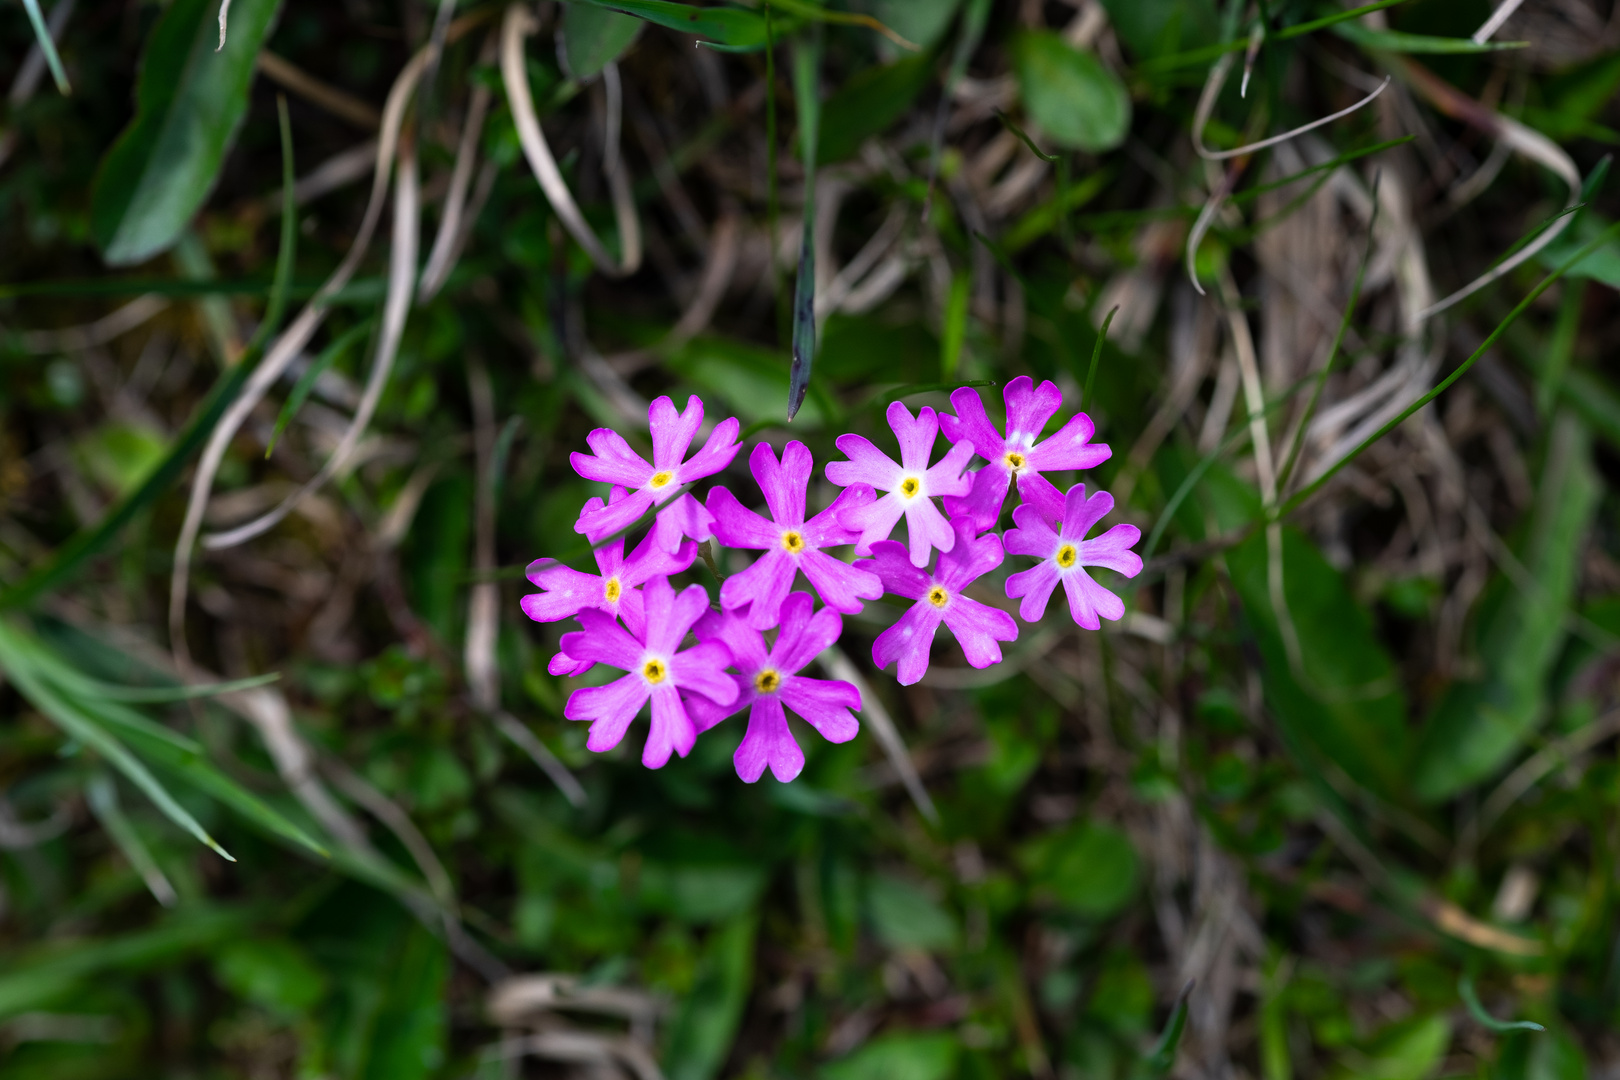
left=664, top=913, right=758, bottom=1080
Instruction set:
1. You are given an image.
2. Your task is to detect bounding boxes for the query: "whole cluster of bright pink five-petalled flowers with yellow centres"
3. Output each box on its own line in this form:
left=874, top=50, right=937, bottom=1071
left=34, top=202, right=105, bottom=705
left=523, top=376, right=1142, bottom=784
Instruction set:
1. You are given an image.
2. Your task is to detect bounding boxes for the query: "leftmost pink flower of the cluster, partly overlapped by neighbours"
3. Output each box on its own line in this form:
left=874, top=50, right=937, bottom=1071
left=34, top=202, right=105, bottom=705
left=522, top=487, right=698, bottom=675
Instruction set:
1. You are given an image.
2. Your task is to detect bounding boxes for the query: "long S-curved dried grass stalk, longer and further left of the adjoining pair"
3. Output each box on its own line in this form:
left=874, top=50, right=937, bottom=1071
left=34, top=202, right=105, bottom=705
left=168, top=50, right=428, bottom=675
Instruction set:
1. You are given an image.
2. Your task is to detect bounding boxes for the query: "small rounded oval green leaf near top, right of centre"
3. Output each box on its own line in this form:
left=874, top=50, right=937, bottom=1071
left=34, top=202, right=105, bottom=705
left=1013, top=31, right=1131, bottom=154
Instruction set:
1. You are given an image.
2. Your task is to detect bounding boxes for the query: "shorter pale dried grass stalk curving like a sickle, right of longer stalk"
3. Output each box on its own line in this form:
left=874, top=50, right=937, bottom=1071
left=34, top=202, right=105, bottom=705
left=203, top=139, right=421, bottom=551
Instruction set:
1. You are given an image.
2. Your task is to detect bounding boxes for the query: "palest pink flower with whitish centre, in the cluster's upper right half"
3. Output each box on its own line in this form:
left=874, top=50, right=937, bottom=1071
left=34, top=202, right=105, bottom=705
left=826, top=402, right=974, bottom=567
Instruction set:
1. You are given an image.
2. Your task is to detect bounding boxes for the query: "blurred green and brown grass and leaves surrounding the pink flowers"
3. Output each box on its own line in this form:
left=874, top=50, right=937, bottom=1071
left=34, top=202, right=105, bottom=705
left=0, top=0, right=1620, bottom=1080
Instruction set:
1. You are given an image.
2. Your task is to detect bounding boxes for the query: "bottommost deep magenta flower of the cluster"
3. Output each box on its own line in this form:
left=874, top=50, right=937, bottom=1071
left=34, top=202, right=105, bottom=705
left=687, top=593, right=860, bottom=784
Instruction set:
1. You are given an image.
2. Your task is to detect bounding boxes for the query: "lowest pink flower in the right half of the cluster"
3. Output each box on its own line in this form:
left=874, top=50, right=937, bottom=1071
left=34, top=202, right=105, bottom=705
left=857, top=520, right=1017, bottom=687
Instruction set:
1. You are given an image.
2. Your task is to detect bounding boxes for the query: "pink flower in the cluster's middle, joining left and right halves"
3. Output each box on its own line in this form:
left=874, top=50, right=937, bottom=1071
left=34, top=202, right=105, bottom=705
left=708, top=442, right=883, bottom=630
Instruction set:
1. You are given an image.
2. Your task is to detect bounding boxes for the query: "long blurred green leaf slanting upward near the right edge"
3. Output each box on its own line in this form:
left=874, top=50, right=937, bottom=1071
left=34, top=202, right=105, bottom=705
left=1413, top=411, right=1602, bottom=801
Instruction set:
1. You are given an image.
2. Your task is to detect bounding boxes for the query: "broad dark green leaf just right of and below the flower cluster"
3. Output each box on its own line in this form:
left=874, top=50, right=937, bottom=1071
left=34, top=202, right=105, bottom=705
left=1224, top=527, right=1406, bottom=797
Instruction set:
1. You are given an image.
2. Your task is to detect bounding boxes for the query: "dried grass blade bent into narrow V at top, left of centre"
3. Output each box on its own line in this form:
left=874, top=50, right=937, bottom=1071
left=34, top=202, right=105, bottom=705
left=501, top=3, right=642, bottom=277
